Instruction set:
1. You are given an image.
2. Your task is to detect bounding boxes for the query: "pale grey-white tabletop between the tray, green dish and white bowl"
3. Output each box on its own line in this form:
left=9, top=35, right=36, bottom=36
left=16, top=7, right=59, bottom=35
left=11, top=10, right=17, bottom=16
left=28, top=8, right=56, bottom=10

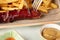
left=0, top=25, right=59, bottom=40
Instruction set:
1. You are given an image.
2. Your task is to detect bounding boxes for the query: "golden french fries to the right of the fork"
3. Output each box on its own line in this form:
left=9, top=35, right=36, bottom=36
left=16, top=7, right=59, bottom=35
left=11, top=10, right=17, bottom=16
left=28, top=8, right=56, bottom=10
left=38, top=0, right=58, bottom=13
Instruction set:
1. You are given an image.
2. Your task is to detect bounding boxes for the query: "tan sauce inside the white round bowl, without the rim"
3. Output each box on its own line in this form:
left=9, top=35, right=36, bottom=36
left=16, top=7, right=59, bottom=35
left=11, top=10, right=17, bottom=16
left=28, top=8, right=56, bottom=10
left=42, top=28, right=60, bottom=40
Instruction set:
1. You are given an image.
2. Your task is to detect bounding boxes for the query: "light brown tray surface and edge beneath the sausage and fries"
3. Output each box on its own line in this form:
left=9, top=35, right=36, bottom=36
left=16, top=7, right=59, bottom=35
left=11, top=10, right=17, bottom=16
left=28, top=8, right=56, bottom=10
left=0, top=0, right=60, bottom=28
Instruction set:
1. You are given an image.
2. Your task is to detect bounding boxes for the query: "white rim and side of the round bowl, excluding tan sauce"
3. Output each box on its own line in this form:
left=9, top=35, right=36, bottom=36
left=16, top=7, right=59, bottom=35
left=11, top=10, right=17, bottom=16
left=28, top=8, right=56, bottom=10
left=40, top=24, right=60, bottom=40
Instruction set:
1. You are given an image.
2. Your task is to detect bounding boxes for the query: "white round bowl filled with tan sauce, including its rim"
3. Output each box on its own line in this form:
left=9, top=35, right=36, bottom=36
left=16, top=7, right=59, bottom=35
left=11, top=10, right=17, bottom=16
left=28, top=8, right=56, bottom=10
left=40, top=24, right=60, bottom=40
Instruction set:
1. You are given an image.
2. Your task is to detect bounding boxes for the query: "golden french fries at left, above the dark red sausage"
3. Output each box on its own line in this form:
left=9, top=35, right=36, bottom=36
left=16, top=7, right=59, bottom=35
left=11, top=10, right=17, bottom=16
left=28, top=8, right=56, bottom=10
left=0, top=0, right=24, bottom=12
